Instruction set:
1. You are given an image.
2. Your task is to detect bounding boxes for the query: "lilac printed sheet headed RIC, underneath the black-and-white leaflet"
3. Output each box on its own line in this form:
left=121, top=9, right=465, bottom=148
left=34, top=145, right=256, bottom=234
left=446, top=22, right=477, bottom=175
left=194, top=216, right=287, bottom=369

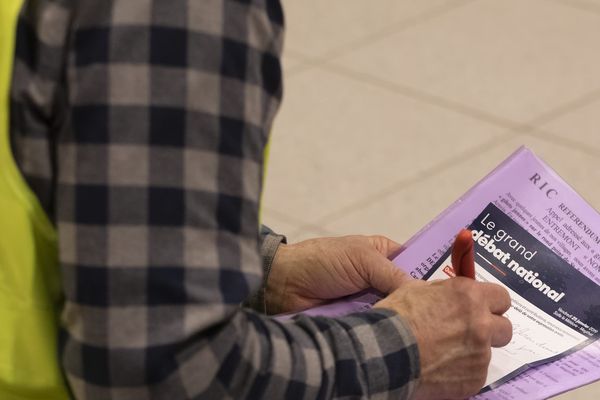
left=284, top=147, right=600, bottom=400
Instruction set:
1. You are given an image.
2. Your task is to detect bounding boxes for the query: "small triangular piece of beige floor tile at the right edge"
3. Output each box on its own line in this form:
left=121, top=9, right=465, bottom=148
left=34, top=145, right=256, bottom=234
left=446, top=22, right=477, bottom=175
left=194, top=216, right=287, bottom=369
left=543, top=99, right=600, bottom=151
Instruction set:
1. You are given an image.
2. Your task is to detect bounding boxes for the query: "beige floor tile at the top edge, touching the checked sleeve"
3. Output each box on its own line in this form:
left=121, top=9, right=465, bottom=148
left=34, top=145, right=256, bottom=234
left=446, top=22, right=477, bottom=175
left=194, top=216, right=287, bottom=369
left=283, top=0, right=457, bottom=57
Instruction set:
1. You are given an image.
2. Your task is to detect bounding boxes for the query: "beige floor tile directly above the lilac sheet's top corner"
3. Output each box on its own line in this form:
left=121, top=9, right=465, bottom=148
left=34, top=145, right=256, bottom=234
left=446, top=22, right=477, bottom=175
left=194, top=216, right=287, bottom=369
left=324, top=136, right=600, bottom=242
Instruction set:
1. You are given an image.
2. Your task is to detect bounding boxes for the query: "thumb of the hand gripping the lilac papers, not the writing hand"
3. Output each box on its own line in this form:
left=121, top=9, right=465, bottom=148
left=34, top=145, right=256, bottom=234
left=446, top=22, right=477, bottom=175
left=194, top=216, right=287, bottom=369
left=362, top=251, right=413, bottom=294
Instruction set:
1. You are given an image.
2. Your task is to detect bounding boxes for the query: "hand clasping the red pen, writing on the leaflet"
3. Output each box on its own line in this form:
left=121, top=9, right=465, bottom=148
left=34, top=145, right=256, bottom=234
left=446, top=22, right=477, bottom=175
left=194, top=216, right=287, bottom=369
left=375, top=277, right=512, bottom=399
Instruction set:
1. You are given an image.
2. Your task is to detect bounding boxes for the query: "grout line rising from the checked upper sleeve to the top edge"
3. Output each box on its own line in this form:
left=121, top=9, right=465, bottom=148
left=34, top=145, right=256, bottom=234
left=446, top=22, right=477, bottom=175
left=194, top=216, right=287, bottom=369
left=286, top=0, right=476, bottom=77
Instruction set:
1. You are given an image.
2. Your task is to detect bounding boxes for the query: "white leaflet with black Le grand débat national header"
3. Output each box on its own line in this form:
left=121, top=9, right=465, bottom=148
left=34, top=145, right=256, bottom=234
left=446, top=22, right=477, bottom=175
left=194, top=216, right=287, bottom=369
left=424, top=204, right=600, bottom=391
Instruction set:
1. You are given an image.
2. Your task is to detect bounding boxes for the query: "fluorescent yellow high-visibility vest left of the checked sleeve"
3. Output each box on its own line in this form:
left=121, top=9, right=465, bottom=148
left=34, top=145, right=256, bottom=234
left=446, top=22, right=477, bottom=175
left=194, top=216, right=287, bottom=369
left=0, top=0, right=69, bottom=400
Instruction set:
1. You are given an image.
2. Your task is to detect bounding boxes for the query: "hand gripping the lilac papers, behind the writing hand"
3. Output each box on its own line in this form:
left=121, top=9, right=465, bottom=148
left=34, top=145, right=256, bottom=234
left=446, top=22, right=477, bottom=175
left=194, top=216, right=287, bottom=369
left=265, top=236, right=412, bottom=314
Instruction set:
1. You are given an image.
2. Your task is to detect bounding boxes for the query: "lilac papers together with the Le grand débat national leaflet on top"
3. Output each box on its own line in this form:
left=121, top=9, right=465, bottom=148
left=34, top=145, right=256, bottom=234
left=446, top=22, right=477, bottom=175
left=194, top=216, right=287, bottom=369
left=286, top=147, right=600, bottom=400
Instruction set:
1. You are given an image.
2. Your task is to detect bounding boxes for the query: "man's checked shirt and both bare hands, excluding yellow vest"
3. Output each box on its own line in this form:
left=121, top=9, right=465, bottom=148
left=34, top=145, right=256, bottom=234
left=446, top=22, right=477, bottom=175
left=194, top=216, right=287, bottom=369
left=5, top=0, right=511, bottom=399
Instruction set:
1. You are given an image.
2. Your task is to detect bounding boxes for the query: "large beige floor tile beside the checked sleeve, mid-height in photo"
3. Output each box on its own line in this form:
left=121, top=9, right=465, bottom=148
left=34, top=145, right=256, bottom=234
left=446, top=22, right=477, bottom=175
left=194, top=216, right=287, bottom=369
left=264, top=70, right=503, bottom=223
